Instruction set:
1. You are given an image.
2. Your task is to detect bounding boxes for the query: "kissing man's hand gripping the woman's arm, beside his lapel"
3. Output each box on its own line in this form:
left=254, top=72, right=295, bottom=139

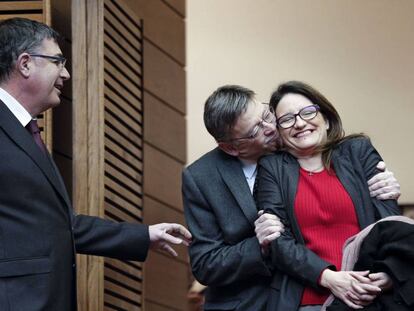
left=254, top=211, right=284, bottom=253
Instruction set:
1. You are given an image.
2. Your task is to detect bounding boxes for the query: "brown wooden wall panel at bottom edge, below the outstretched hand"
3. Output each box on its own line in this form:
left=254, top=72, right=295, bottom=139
left=145, top=252, right=188, bottom=310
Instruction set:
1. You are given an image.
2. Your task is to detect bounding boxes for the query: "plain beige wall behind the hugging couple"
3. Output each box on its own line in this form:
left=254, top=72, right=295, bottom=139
left=187, top=0, right=414, bottom=203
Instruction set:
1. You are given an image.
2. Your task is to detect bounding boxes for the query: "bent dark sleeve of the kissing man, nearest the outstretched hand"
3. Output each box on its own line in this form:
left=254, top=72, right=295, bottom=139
left=182, top=169, right=271, bottom=286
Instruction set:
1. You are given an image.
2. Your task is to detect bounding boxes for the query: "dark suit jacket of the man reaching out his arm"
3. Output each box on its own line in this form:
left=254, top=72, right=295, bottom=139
left=0, top=101, right=149, bottom=311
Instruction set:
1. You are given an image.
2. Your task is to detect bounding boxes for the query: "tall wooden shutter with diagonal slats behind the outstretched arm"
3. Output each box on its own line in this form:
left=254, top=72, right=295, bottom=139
left=104, top=0, right=143, bottom=311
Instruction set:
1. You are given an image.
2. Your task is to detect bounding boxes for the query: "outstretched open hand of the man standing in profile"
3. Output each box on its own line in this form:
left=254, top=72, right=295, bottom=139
left=148, top=223, right=191, bottom=256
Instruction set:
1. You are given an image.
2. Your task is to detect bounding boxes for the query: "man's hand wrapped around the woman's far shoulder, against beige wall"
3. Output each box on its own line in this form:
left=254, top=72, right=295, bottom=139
left=368, top=161, right=401, bottom=200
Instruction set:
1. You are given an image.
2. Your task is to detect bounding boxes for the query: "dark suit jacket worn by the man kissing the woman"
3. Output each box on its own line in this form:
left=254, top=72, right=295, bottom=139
left=183, top=148, right=271, bottom=311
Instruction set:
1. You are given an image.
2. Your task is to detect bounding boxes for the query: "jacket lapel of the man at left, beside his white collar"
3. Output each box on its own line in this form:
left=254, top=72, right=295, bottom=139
left=0, top=101, right=70, bottom=211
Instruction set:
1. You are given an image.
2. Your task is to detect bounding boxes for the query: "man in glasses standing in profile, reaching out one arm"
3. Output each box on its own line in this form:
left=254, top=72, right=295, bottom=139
left=0, top=18, right=191, bottom=311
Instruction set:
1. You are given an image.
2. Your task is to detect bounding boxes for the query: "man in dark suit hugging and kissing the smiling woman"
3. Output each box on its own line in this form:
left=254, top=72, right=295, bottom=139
left=182, top=86, right=399, bottom=311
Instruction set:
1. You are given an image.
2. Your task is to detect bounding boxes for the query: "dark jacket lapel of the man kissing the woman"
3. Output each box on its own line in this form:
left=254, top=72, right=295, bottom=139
left=217, top=155, right=257, bottom=226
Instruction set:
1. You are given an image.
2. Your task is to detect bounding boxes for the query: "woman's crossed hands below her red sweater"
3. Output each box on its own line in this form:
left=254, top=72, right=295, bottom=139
left=320, top=269, right=381, bottom=309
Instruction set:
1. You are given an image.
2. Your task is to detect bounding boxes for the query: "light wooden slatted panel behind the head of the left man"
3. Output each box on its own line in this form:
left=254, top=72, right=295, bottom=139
left=0, top=0, right=52, bottom=150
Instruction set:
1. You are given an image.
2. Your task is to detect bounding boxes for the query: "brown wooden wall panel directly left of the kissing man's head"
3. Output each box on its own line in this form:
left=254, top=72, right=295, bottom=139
left=144, top=92, right=186, bottom=164
